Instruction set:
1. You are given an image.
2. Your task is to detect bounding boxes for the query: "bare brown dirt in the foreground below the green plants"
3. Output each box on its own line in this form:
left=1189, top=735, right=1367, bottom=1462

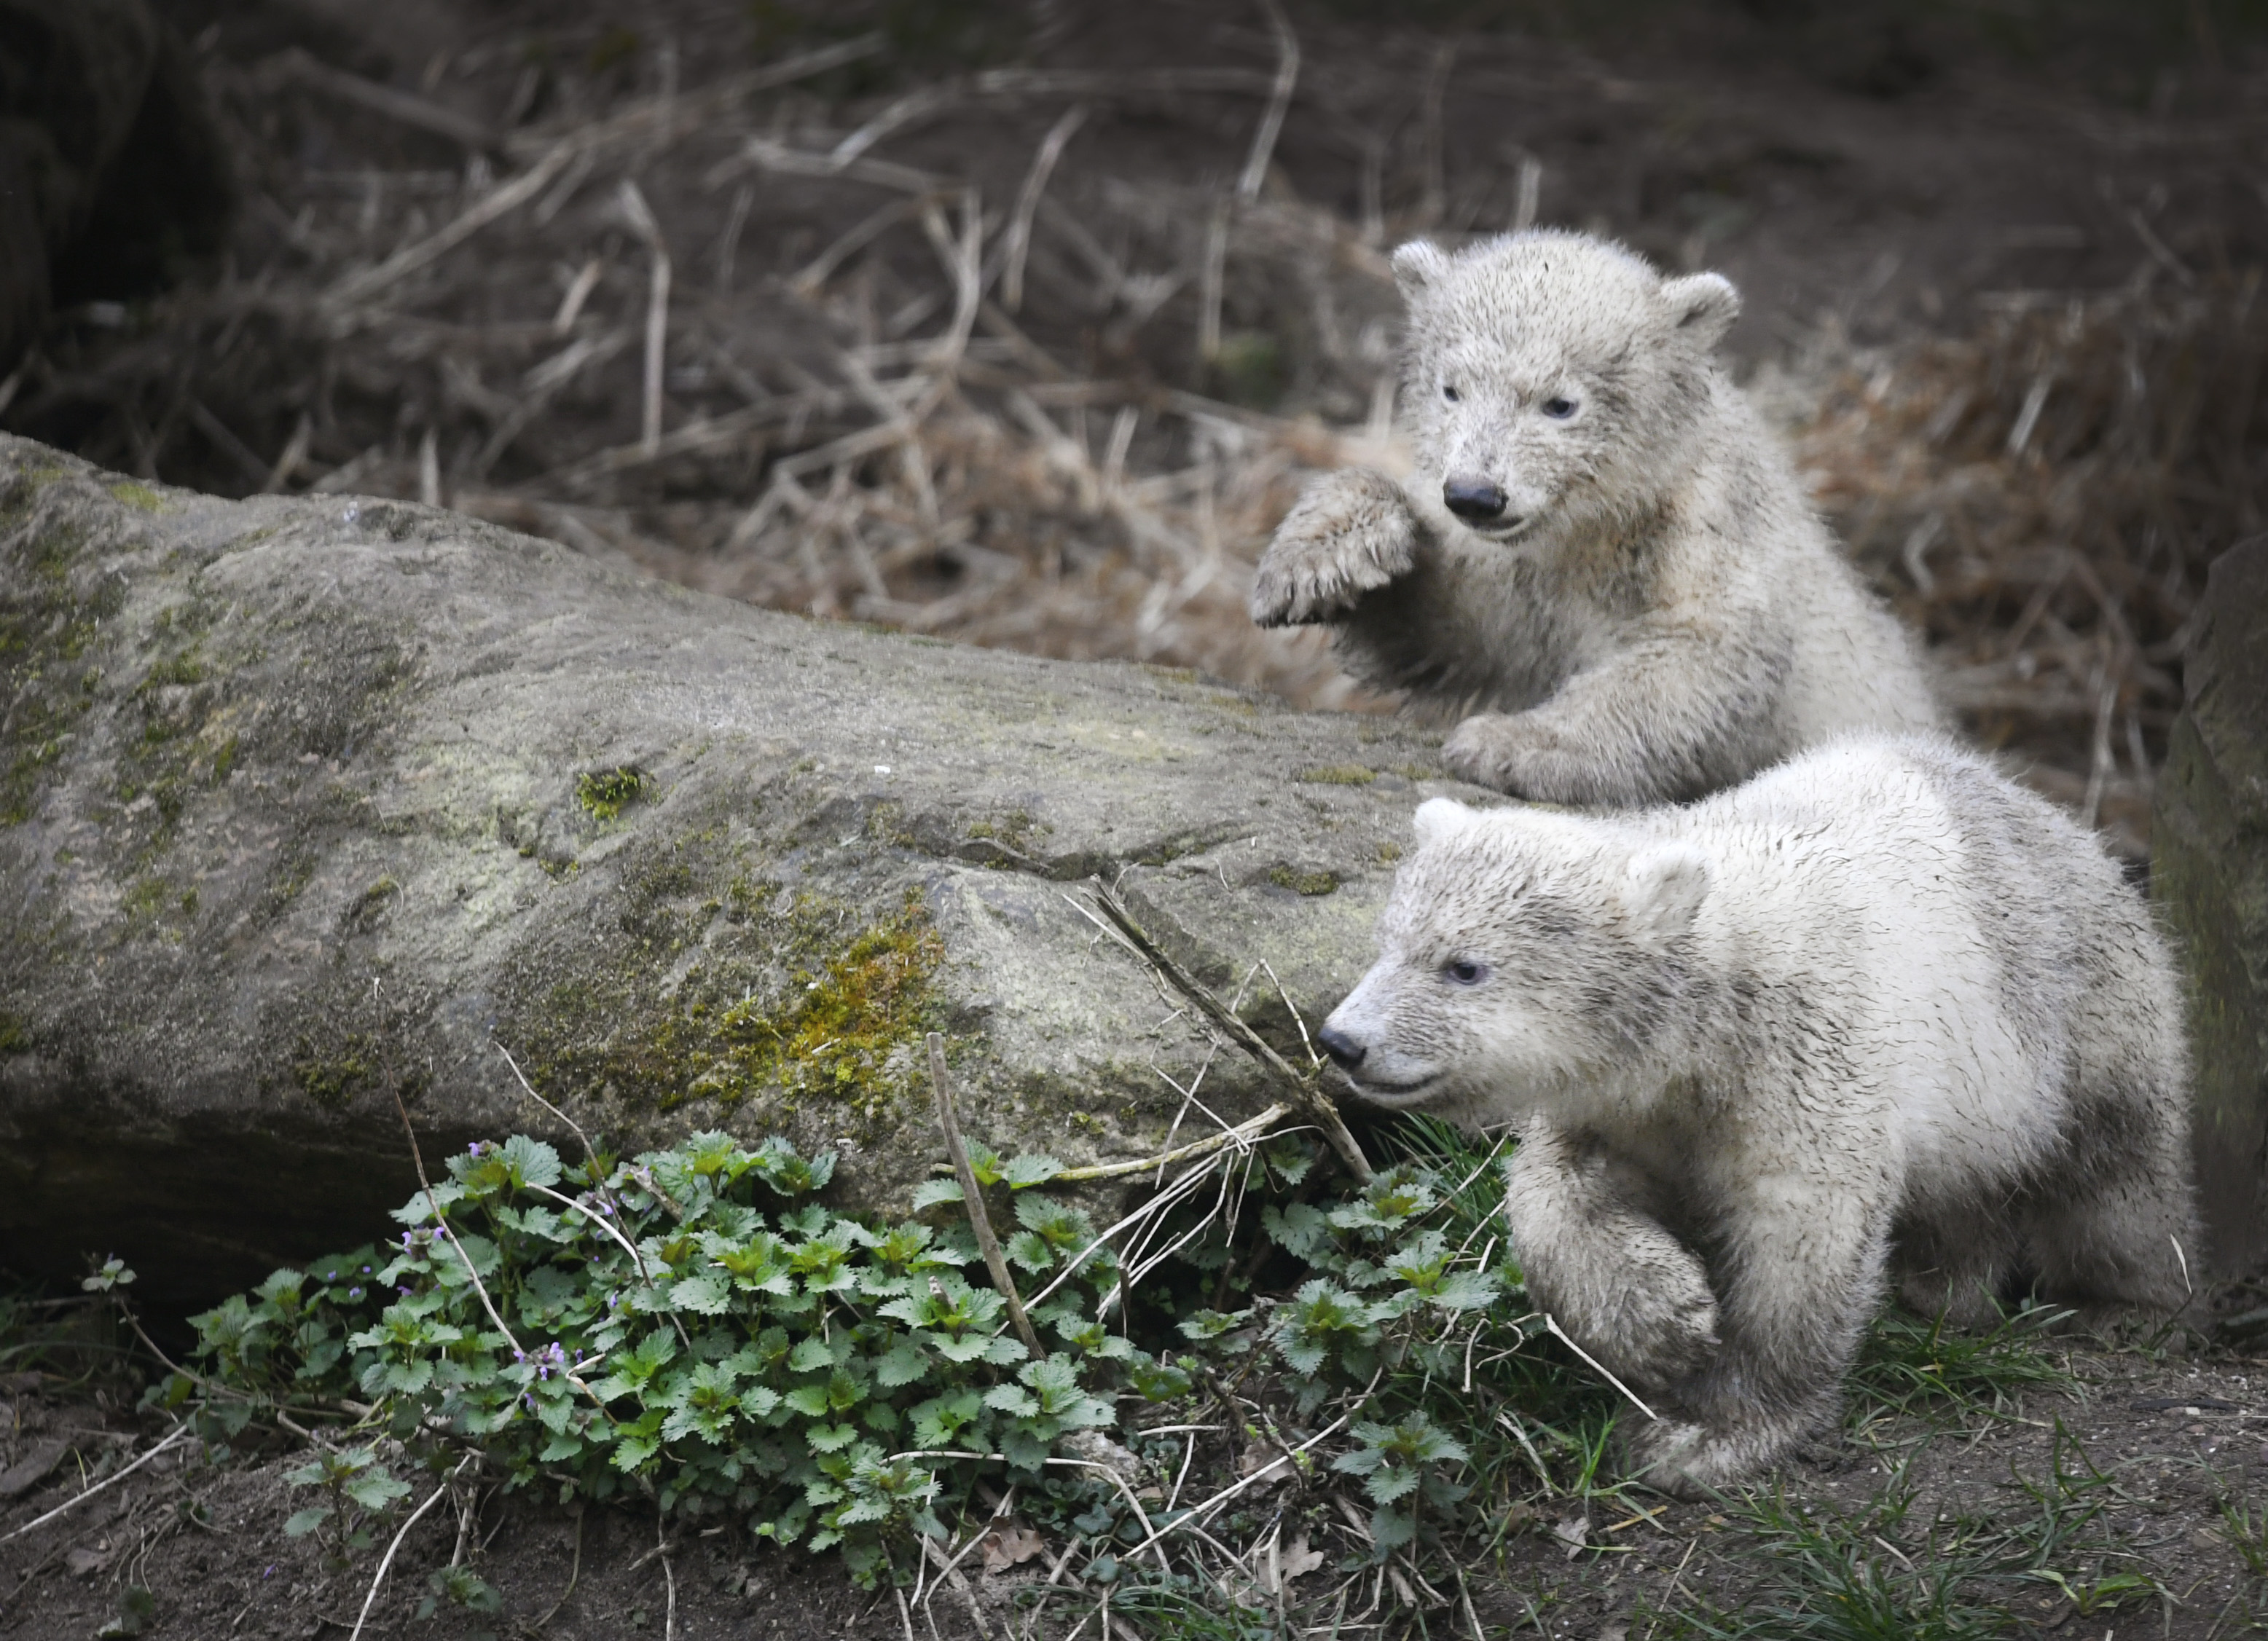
left=0, top=1351, right=2268, bottom=1641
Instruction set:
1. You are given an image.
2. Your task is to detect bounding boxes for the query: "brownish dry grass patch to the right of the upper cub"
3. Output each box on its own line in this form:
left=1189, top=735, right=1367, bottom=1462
left=1801, top=274, right=2268, bottom=859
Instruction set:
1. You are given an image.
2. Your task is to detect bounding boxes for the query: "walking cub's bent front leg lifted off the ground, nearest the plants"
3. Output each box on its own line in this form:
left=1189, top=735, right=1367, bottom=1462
left=1504, top=1117, right=1717, bottom=1390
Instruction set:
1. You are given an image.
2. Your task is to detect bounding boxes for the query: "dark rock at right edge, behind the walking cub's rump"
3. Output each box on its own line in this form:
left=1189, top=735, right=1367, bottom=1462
left=2150, top=540, right=2268, bottom=1274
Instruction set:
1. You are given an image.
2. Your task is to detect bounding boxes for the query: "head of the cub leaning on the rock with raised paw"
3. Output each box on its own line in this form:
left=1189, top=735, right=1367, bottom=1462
left=1392, top=229, right=1740, bottom=542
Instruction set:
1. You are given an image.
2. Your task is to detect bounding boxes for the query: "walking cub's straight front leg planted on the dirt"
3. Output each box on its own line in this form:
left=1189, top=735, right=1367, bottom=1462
left=1631, top=1149, right=1891, bottom=1496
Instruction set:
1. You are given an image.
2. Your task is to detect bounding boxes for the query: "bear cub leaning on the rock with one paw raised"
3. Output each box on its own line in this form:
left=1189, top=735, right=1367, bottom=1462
left=1252, top=231, right=1939, bottom=807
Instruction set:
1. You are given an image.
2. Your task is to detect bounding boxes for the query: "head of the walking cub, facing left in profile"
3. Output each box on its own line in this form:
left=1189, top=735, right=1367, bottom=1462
left=1318, top=798, right=1714, bottom=1119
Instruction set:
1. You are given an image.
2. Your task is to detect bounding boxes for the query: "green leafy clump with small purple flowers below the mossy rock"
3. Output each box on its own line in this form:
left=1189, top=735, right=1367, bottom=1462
left=174, top=1133, right=1161, bottom=1582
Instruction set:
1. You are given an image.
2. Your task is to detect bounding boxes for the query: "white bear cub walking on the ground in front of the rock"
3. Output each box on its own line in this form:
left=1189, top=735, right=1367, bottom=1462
left=1320, top=739, right=2197, bottom=1492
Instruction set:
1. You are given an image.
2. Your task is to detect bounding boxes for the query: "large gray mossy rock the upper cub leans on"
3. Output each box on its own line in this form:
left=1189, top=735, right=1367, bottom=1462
left=0, top=440, right=1477, bottom=1301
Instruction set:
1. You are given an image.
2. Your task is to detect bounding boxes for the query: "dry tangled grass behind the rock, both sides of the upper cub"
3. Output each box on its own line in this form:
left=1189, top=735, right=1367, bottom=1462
left=0, top=9, right=2264, bottom=854
